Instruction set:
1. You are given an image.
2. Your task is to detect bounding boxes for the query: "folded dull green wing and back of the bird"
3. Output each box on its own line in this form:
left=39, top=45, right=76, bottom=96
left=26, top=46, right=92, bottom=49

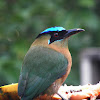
left=18, top=46, right=68, bottom=100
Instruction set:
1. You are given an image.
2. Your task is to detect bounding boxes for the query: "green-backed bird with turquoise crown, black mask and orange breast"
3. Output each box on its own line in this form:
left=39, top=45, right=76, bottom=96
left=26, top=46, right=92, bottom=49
left=18, top=26, right=84, bottom=100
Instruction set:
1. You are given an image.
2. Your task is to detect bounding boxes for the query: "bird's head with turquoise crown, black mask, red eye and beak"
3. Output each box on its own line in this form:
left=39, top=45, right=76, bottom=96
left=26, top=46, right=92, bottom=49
left=37, top=27, right=84, bottom=45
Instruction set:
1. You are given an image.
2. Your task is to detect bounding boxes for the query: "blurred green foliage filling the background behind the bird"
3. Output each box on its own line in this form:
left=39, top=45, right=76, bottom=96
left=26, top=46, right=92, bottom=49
left=0, top=0, right=100, bottom=85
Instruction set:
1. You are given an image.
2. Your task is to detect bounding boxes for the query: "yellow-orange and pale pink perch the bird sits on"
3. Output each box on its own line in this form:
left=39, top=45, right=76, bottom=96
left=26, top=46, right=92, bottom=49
left=0, top=83, right=100, bottom=100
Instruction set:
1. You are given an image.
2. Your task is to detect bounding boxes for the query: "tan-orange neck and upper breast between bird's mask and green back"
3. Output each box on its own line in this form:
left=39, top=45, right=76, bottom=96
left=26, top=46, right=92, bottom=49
left=31, top=35, right=72, bottom=64
